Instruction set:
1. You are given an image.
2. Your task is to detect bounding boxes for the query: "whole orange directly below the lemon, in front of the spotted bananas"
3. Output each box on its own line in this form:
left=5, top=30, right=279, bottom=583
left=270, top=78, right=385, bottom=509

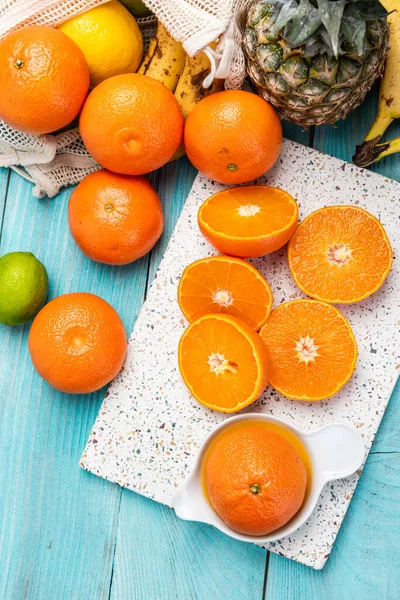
left=80, top=73, right=183, bottom=175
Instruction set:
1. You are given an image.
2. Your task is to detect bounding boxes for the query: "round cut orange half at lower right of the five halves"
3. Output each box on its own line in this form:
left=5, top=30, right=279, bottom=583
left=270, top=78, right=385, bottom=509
left=260, top=299, right=357, bottom=402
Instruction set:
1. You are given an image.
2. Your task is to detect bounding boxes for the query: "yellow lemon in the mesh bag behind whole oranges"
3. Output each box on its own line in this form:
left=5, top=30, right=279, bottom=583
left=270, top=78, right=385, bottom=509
left=58, top=0, right=143, bottom=87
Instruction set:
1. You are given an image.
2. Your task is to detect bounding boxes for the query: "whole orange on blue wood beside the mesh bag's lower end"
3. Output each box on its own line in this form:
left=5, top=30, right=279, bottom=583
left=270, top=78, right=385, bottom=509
left=68, top=169, right=164, bottom=265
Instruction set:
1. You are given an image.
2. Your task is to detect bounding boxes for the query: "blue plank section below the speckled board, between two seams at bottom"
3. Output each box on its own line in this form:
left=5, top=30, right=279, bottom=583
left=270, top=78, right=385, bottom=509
left=111, top=492, right=266, bottom=600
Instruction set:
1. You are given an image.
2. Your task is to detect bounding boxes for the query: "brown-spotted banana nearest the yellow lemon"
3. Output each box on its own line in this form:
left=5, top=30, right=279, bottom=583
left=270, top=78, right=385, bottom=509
left=137, top=21, right=185, bottom=92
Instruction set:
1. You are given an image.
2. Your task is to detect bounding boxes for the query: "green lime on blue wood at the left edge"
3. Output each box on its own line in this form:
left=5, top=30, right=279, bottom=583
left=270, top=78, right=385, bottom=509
left=0, top=252, right=48, bottom=325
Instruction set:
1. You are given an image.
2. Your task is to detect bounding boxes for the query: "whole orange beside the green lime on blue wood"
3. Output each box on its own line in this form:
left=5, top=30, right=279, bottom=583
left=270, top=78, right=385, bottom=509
left=28, top=292, right=127, bottom=394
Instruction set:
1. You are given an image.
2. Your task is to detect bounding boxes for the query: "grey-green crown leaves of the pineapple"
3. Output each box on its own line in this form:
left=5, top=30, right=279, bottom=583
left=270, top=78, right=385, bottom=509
left=267, top=0, right=388, bottom=58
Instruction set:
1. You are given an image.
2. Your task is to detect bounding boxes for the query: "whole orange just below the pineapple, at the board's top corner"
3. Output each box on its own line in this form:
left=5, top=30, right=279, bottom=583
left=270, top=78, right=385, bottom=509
left=185, top=90, right=282, bottom=183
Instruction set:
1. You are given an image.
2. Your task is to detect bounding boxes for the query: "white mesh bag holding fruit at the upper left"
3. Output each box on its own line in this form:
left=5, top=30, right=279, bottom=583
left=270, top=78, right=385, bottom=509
left=0, top=0, right=253, bottom=198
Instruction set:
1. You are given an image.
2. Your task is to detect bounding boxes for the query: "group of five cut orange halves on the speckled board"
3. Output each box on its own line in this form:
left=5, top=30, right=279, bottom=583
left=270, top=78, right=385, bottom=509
left=178, top=186, right=392, bottom=413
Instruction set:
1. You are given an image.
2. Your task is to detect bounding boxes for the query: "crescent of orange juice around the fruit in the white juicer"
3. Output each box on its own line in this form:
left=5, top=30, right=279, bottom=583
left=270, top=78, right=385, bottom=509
left=201, top=417, right=312, bottom=504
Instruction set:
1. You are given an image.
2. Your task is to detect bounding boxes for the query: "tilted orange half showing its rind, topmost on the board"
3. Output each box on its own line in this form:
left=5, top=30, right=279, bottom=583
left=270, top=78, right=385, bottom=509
left=198, top=185, right=298, bottom=258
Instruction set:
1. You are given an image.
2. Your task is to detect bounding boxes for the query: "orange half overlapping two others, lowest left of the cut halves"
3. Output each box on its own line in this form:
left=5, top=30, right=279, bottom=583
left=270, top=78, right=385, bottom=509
left=178, top=314, right=269, bottom=413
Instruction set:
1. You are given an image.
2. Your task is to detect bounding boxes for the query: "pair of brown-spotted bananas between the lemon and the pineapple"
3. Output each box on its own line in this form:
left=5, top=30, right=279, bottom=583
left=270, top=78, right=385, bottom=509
left=137, top=22, right=225, bottom=161
